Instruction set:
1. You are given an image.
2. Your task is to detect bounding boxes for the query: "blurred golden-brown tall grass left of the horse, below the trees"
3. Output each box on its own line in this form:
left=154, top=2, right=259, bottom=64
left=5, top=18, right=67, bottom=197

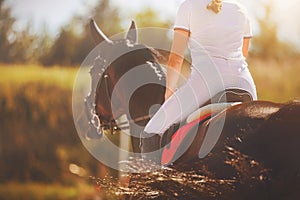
left=0, top=66, right=98, bottom=183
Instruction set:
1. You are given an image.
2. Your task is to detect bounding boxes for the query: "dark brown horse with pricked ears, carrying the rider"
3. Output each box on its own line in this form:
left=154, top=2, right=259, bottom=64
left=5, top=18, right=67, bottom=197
left=86, top=20, right=300, bottom=198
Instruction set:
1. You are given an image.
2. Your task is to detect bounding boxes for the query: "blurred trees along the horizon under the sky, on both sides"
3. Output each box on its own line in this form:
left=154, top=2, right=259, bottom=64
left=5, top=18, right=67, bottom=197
left=0, top=0, right=299, bottom=66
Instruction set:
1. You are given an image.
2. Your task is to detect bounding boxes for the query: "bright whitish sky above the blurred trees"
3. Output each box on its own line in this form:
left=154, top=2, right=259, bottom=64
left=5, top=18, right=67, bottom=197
left=7, top=0, right=300, bottom=49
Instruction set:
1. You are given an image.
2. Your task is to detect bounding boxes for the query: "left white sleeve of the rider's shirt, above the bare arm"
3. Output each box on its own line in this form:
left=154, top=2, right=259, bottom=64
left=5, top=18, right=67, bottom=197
left=174, top=1, right=190, bottom=31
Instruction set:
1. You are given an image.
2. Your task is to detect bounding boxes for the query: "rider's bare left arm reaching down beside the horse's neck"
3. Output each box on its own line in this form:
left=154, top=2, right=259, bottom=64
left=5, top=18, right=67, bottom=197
left=165, top=29, right=190, bottom=99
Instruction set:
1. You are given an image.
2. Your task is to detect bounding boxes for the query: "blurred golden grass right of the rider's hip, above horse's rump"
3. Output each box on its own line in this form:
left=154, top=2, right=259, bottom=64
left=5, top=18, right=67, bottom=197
left=249, top=58, right=300, bottom=102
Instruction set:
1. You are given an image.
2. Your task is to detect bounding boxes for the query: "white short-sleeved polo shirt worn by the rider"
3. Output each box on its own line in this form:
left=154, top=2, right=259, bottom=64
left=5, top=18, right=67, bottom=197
left=174, top=0, right=252, bottom=60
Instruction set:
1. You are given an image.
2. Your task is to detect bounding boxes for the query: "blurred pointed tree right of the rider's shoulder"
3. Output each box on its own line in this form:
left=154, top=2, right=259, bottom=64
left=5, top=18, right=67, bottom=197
left=251, top=4, right=296, bottom=59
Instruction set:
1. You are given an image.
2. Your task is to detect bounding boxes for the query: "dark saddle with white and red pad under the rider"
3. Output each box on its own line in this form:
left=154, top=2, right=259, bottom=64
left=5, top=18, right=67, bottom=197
left=161, top=89, right=253, bottom=164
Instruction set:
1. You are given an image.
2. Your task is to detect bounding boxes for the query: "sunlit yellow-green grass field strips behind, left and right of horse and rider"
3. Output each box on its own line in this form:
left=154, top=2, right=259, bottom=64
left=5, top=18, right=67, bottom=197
left=0, top=58, right=300, bottom=102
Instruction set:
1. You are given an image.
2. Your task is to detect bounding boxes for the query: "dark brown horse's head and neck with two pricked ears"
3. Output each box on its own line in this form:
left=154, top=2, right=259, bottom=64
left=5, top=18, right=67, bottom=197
left=85, top=20, right=165, bottom=139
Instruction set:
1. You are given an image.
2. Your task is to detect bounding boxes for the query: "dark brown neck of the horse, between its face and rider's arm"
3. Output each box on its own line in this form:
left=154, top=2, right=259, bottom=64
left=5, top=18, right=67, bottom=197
left=112, top=61, right=166, bottom=119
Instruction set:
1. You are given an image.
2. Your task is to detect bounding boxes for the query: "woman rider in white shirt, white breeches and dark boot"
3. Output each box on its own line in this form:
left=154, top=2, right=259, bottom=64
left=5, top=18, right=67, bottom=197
left=141, top=0, right=257, bottom=162
